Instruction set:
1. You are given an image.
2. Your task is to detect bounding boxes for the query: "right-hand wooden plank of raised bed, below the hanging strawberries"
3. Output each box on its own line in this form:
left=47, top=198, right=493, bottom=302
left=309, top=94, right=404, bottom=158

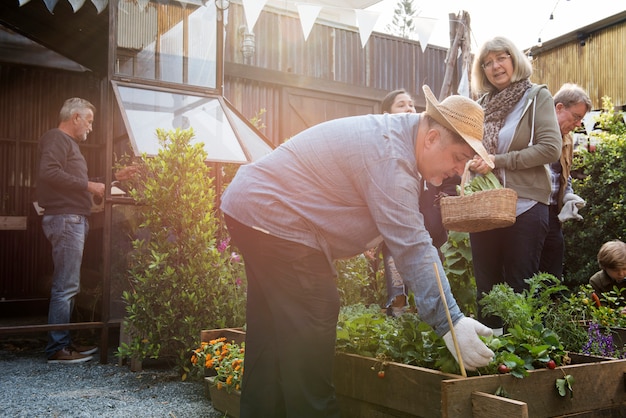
left=441, top=360, right=626, bottom=418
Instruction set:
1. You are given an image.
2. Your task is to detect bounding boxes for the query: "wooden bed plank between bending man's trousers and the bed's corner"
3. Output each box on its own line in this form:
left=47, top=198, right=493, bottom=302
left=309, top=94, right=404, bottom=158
left=334, top=353, right=461, bottom=418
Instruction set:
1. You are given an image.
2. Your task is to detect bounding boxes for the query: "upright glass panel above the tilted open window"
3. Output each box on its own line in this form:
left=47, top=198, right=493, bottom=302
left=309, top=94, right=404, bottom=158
left=115, top=0, right=217, bottom=88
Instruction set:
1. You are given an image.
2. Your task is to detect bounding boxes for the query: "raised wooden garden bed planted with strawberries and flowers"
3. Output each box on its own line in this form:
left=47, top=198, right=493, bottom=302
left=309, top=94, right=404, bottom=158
left=201, top=329, right=626, bottom=418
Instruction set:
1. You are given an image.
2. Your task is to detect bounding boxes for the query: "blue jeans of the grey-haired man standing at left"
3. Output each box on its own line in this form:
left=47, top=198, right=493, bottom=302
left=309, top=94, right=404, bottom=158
left=41, top=215, right=89, bottom=357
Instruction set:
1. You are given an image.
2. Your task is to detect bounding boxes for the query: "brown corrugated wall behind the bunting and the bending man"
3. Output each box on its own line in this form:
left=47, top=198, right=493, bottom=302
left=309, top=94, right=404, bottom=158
left=224, top=4, right=450, bottom=144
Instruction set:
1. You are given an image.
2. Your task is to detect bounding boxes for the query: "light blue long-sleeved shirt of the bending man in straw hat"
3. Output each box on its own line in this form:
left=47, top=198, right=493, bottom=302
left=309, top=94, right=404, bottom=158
left=221, top=113, right=463, bottom=335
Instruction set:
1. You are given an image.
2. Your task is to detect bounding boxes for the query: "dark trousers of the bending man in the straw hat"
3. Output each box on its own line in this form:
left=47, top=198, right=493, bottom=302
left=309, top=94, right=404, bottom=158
left=225, top=216, right=339, bottom=418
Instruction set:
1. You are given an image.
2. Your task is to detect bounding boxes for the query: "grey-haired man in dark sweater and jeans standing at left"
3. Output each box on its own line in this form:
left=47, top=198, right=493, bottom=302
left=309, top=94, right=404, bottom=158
left=37, top=98, right=104, bottom=363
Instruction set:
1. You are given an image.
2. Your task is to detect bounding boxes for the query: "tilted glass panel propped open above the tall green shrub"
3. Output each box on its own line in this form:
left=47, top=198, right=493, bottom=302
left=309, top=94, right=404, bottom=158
left=114, top=86, right=250, bottom=163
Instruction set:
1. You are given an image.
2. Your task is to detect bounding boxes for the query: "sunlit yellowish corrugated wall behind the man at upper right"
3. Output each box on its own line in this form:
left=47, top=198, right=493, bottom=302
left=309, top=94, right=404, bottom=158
left=532, top=22, right=626, bottom=109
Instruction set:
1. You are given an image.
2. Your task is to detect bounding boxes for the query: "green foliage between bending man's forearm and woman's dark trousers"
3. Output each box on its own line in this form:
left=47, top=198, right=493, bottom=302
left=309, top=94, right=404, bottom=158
left=441, top=231, right=476, bottom=316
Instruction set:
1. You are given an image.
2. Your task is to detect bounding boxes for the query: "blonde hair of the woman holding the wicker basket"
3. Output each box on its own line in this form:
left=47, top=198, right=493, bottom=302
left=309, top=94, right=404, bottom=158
left=472, top=36, right=533, bottom=95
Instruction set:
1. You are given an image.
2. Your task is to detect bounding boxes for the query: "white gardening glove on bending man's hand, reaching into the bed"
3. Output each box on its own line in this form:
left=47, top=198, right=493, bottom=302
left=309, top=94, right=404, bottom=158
left=443, top=317, right=493, bottom=370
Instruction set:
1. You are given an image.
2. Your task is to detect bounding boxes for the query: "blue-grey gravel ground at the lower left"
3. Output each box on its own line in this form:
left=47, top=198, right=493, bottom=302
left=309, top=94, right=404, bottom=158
left=0, top=337, right=223, bottom=418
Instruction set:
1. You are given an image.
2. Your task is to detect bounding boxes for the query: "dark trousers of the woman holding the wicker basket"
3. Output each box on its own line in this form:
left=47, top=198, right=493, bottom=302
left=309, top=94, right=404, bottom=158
left=470, top=203, right=548, bottom=328
